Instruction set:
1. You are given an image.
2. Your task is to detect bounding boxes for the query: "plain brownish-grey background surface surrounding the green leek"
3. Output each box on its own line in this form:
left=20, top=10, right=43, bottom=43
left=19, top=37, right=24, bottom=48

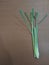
left=0, top=0, right=49, bottom=65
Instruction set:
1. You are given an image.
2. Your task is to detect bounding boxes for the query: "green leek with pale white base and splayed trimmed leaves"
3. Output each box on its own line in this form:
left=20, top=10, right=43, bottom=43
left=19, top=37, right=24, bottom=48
left=20, top=8, right=47, bottom=59
